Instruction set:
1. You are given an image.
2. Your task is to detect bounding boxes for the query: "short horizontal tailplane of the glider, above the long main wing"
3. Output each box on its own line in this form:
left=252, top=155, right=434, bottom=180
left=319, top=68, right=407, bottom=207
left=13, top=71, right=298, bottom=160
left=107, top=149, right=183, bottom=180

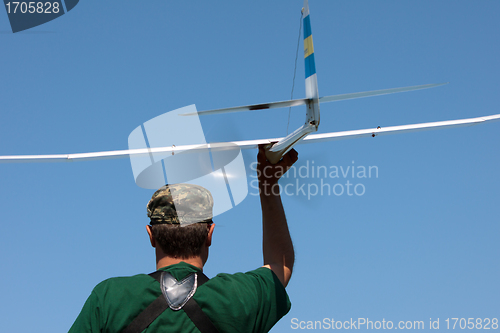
left=182, top=82, right=448, bottom=116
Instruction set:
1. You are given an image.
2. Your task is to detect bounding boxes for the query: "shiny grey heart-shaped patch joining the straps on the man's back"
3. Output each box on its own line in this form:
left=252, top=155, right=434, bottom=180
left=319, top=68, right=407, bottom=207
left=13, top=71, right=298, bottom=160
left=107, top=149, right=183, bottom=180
left=160, top=272, right=198, bottom=310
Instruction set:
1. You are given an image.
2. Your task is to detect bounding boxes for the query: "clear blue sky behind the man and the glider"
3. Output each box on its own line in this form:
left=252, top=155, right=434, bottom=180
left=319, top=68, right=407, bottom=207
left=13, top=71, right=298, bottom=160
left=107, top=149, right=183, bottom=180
left=0, top=0, right=500, bottom=332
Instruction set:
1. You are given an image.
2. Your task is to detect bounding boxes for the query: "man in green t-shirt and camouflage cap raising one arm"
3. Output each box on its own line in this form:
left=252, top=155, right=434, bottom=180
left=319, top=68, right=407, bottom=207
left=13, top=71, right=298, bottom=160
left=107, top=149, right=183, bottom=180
left=70, top=146, right=298, bottom=333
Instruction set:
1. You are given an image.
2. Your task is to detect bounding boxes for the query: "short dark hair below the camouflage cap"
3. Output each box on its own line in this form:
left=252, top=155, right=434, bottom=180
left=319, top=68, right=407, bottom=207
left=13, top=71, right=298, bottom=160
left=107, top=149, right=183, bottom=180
left=151, top=223, right=212, bottom=259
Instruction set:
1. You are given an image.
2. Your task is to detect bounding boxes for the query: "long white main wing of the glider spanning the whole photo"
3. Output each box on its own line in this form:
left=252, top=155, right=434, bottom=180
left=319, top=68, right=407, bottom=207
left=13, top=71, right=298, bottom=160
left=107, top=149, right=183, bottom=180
left=0, top=114, right=500, bottom=163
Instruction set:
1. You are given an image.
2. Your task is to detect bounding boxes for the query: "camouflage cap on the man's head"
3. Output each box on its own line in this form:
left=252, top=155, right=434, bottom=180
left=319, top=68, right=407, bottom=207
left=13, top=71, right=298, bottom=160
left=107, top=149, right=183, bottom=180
left=147, top=184, right=214, bottom=226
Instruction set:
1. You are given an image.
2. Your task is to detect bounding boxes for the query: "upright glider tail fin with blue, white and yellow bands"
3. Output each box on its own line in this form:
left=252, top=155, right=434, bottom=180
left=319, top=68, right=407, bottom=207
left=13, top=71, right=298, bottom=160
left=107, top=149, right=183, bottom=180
left=302, top=0, right=319, bottom=129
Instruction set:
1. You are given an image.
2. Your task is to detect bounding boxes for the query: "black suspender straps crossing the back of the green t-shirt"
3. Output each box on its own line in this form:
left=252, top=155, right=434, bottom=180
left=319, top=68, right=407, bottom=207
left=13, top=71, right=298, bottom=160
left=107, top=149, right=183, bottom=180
left=121, top=271, right=219, bottom=333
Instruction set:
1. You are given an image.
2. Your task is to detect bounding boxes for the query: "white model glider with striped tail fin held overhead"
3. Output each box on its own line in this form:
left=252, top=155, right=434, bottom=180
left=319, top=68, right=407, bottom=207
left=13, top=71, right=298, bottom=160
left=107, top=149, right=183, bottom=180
left=0, top=0, right=500, bottom=163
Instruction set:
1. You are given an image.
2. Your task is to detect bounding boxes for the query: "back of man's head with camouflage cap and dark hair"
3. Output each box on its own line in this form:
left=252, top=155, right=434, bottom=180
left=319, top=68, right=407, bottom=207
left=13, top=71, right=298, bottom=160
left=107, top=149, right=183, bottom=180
left=147, top=184, right=214, bottom=259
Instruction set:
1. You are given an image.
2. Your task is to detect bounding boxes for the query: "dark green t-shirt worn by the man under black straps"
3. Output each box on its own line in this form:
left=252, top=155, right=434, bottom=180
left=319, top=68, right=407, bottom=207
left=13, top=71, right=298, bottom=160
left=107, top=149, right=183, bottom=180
left=69, top=262, right=291, bottom=333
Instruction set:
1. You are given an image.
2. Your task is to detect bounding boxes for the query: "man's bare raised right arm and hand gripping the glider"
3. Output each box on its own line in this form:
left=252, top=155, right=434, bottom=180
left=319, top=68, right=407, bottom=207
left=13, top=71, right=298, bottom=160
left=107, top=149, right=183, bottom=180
left=257, top=145, right=298, bottom=287
